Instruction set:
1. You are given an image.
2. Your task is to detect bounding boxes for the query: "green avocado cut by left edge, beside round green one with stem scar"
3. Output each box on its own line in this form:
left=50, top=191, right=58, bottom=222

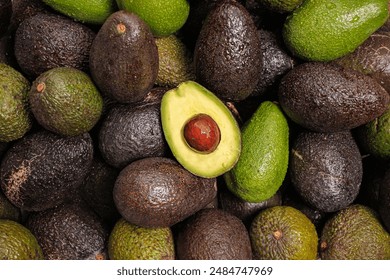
left=0, top=63, right=32, bottom=142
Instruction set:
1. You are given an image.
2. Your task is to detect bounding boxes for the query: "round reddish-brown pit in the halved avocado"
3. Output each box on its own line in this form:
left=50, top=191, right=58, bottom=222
left=183, top=114, right=221, bottom=153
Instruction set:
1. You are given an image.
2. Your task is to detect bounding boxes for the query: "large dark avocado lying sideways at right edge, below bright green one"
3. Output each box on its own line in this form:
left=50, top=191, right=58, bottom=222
left=278, top=62, right=390, bottom=132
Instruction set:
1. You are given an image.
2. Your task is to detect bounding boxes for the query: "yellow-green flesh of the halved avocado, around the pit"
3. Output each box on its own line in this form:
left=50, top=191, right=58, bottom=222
left=161, top=81, right=241, bottom=178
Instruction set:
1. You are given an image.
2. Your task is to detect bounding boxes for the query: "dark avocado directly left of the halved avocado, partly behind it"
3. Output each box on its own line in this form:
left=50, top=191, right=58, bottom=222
left=99, top=102, right=168, bottom=169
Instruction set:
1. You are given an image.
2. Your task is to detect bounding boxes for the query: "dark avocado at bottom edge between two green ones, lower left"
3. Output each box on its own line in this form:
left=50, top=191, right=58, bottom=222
left=26, top=203, right=108, bottom=260
